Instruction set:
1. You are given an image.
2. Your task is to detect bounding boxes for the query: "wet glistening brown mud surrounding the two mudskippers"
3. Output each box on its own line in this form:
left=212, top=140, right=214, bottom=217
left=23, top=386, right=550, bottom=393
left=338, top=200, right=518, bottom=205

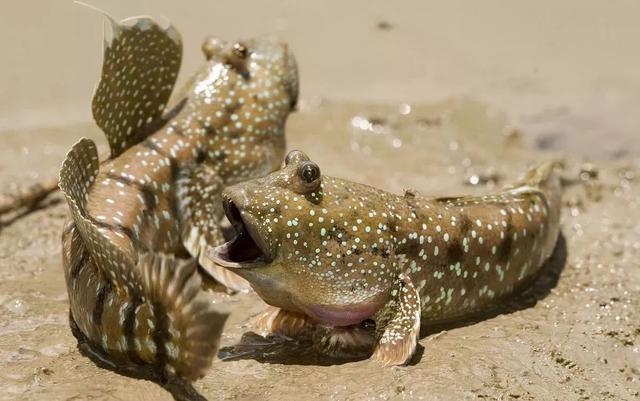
left=0, top=99, right=640, bottom=400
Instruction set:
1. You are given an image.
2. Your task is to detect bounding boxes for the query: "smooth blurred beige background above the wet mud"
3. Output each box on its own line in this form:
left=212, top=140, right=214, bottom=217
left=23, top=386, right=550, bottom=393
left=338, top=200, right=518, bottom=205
left=0, top=0, right=640, bottom=158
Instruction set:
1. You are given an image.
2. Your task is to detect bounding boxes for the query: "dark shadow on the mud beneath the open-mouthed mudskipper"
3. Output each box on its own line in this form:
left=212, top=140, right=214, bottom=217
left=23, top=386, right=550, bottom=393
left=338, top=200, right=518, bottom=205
left=218, top=232, right=567, bottom=366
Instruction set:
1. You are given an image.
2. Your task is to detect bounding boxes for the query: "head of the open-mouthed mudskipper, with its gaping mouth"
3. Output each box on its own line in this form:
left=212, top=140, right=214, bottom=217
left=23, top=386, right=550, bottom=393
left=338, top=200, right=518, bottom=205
left=208, top=151, right=397, bottom=326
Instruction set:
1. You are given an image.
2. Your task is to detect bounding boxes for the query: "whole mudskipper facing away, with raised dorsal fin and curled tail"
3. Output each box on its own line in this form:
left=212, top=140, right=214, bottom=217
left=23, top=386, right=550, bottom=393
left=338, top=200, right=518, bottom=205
left=60, top=12, right=297, bottom=380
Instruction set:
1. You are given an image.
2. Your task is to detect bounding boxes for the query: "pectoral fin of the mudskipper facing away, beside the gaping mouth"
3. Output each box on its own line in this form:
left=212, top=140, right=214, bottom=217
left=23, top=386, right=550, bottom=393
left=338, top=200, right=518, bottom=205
left=176, top=164, right=251, bottom=291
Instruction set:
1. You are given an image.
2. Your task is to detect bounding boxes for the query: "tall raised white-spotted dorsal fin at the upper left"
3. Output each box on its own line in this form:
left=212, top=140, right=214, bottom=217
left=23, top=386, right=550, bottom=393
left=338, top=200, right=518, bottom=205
left=91, top=9, right=182, bottom=158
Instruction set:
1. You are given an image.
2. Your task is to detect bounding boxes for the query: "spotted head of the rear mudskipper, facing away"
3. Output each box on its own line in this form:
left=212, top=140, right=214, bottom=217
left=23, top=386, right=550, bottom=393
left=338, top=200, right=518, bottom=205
left=195, top=37, right=298, bottom=175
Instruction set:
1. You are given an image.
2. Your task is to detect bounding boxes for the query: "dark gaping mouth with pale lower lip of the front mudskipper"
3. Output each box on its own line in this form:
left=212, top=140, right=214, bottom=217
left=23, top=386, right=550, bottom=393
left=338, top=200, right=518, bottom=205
left=208, top=199, right=271, bottom=269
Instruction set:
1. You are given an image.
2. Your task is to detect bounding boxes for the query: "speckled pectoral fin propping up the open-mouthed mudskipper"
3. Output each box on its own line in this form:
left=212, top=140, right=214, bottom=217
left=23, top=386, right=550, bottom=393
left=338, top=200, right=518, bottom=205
left=371, top=274, right=420, bottom=366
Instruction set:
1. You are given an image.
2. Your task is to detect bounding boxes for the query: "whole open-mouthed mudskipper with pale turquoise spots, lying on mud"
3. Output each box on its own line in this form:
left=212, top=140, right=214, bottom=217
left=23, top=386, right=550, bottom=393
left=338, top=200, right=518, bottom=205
left=209, top=152, right=561, bottom=364
